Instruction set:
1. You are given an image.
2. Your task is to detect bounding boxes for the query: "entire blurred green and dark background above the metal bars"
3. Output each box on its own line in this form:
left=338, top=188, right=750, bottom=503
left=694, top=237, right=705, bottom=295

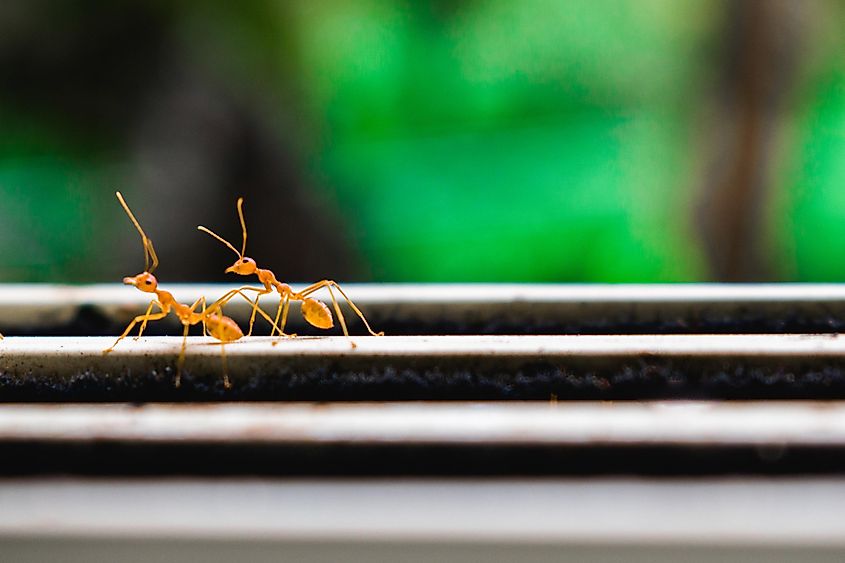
left=0, top=0, right=845, bottom=283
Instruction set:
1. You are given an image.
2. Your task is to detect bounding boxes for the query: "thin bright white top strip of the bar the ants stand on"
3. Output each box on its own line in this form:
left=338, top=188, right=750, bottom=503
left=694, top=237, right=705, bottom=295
left=0, top=334, right=845, bottom=360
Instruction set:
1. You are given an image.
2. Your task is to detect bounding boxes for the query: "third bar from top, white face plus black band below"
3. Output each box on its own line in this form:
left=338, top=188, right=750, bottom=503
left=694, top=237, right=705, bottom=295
left=0, top=402, right=845, bottom=477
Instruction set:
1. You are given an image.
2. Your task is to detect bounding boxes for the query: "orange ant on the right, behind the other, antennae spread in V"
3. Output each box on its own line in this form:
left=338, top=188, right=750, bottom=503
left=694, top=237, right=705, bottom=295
left=197, top=197, right=384, bottom=347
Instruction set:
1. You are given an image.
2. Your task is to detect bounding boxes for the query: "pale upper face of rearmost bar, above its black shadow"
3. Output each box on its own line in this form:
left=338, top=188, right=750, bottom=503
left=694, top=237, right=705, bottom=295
left=0, top=280, right=845, bottom=333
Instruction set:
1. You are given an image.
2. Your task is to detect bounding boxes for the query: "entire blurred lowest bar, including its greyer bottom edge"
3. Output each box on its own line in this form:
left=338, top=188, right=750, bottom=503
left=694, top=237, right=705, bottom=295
left=0, top=478, right=845, bottom=552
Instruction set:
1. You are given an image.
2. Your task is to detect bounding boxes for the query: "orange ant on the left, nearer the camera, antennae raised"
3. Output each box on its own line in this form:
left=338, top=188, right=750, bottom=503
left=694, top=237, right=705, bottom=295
left=103, top=192, right=272, bottom=388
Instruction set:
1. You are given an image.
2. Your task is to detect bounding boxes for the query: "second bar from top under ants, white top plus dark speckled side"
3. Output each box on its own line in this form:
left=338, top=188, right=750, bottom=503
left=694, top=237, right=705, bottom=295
left=0, top=335, right=845, bottom=401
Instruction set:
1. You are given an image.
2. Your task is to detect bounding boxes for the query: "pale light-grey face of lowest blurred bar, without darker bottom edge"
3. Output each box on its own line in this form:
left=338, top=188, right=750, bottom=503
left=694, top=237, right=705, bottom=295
left=0, top=479, right=845, bottom=547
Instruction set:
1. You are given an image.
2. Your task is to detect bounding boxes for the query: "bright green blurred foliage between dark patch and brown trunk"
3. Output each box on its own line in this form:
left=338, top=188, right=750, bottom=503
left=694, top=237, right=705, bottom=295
left=297, top=1, right=715, bottom=281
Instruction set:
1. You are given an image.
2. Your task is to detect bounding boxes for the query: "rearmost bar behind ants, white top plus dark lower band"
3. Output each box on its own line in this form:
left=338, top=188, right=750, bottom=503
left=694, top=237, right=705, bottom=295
left=0, top=284, right=845, bottom=335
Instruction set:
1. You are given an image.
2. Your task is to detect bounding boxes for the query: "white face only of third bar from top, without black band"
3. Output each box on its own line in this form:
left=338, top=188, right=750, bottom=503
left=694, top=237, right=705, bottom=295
left=0, top=402, right=845, bottom=448
